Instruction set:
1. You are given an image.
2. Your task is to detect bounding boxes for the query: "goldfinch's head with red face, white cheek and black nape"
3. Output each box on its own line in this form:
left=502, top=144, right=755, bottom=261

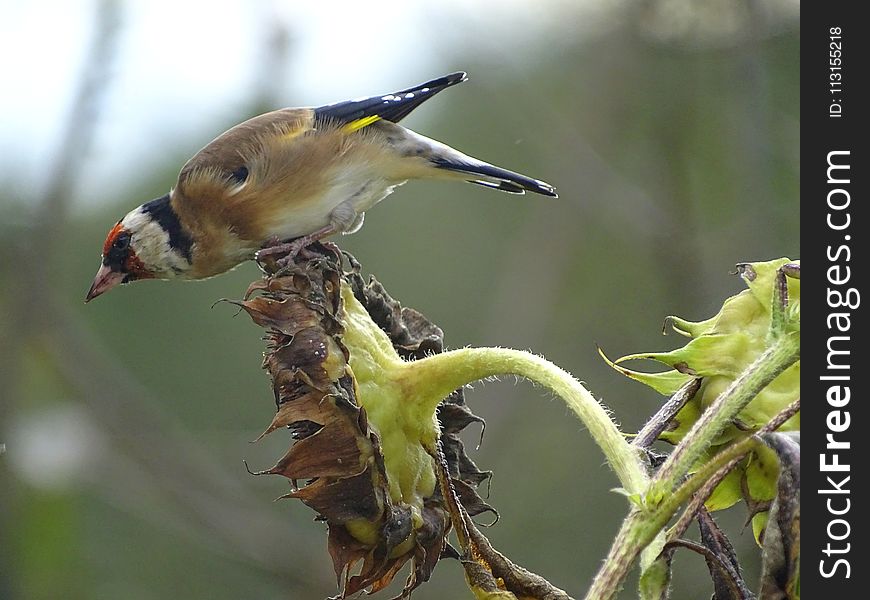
left=85, top=194, right=191, bottom=302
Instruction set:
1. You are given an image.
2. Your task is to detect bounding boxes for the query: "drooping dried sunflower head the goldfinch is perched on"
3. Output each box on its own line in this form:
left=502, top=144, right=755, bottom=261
left=238, top=246, right=495, bottom=598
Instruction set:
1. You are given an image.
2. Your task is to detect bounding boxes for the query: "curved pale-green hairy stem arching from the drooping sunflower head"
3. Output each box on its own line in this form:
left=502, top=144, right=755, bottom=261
left=405, top=348, right=648, bottom=494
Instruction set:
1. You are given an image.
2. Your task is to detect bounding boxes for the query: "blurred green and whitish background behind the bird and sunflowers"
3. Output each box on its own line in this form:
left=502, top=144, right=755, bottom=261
left=0, top=0, right=800, bottom=600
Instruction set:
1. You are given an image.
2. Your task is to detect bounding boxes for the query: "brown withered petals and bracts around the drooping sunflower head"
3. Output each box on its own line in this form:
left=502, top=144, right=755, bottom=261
left=242, top=244, right=497, bottom=598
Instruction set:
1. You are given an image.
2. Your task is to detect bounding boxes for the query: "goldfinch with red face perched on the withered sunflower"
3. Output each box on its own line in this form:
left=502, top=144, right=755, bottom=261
left=85, top=72, right=557, bottom=302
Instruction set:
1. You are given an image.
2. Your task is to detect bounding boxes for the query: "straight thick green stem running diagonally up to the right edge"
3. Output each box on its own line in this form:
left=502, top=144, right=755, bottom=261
left=586, top=334, right=800, bottom=600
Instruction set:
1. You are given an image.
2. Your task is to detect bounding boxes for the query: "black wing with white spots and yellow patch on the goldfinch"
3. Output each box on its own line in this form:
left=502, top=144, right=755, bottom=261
left=314, top=71, right=467, bottom=131
